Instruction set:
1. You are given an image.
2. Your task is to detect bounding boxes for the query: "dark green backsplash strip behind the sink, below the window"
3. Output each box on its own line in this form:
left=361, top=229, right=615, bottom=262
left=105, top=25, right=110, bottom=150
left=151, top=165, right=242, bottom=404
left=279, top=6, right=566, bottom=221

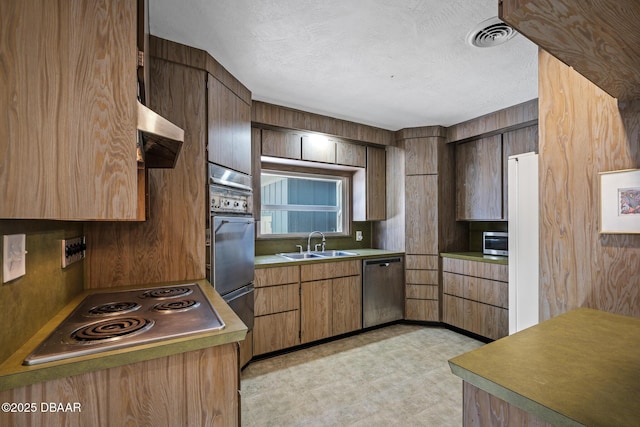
left=256, top=221, right=371, bottom=255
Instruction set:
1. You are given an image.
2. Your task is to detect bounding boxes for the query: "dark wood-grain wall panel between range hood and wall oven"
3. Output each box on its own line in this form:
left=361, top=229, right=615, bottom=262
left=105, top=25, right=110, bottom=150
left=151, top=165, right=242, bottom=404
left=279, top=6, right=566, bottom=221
left=85, top=58, right=207, bottom=288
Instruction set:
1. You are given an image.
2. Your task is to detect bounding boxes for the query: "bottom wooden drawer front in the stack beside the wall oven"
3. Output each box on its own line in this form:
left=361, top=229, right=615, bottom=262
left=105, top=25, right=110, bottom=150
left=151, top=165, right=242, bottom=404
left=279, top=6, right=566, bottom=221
left=253, top=310, right=300, bottom=356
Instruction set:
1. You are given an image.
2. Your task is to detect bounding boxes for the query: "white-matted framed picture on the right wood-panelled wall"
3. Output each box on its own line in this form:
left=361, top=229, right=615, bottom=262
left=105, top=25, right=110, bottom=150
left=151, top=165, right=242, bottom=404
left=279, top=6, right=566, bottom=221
left=600, top=169, right=640, bottom=234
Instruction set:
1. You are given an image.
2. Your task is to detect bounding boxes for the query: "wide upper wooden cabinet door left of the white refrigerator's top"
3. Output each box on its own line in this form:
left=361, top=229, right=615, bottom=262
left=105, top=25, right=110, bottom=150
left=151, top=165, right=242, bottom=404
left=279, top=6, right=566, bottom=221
left=456, top=135, right=502, bottom=220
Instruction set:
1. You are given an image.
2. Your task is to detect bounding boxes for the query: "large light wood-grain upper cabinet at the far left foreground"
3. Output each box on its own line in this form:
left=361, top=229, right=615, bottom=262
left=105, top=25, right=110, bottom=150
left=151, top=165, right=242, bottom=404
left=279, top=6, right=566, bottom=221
left=0, top=0, right=144, bottom=220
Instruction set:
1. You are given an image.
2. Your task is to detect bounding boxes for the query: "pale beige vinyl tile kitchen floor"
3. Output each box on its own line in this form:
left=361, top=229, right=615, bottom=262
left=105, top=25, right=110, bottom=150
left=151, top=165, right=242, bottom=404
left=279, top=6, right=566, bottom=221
left=241, top=324, right=483, bottom=427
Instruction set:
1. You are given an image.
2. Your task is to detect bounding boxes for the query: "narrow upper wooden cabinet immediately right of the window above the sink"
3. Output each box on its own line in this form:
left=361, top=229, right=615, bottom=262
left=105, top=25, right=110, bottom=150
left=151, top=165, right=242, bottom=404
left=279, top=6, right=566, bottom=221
left=353, top=146, right=387, bottom=221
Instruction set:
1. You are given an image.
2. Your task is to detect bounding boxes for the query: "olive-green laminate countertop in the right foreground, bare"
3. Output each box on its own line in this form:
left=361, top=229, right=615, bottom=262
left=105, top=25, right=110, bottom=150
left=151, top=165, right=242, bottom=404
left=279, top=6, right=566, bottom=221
left=449, top=308, right=640, bottom=427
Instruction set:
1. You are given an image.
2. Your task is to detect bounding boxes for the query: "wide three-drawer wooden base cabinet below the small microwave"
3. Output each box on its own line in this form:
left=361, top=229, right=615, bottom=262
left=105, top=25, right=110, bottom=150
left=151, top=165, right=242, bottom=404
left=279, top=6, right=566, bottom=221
left=442, top=258, right=509, bottom=340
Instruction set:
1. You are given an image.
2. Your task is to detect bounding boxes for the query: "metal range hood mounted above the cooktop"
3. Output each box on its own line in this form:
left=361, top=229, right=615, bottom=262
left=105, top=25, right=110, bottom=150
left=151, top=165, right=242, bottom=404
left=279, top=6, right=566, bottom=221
left=138, top=101, right=184, bottom=168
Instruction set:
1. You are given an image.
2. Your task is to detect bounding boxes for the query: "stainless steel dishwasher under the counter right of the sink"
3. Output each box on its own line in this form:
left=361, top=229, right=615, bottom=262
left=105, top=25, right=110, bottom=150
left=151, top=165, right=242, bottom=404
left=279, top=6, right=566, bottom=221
left=362, top=257, right=404, bottom=328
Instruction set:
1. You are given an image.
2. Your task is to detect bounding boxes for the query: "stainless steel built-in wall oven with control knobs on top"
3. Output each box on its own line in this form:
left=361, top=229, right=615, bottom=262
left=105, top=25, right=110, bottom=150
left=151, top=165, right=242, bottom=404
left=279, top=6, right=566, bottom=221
left=207, top=163, right=255, bottom=330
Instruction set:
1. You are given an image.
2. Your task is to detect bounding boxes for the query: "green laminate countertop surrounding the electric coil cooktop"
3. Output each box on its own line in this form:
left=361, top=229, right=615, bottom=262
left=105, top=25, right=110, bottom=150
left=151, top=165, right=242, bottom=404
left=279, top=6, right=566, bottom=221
left=0, top=280, right=247, bottom=390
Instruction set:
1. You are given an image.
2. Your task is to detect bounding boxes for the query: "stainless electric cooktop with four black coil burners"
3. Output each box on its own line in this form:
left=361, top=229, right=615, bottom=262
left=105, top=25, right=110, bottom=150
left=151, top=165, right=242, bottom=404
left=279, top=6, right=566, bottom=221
left=23, top=283, right=225, bottom=365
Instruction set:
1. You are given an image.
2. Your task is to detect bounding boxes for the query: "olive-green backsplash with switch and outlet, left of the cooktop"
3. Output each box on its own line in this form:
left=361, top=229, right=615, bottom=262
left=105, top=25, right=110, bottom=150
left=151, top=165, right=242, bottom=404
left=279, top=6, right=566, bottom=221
left=0, top=220, right=84, bottom=363
